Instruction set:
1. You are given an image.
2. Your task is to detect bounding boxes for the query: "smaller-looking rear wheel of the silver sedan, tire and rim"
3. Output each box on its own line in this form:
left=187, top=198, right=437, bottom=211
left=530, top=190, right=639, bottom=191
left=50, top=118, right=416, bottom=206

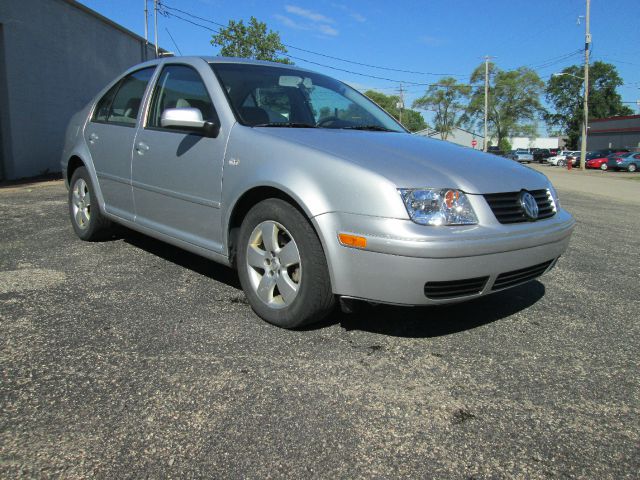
left=68, top=167, right=111, bottom=242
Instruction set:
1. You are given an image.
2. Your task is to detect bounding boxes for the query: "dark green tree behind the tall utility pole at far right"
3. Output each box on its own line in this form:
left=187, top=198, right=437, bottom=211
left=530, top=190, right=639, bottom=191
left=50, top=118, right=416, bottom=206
left=545, top=61, right=633, bottom=148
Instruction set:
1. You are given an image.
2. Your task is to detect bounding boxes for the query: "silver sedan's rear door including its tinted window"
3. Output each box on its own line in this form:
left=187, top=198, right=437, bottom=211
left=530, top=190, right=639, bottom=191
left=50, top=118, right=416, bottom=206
left=84, top=67, right=155, bottom=220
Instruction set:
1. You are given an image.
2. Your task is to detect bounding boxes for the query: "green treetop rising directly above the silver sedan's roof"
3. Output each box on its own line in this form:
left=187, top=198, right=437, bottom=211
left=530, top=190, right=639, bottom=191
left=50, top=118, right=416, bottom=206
left=211, top=17, right=293, bottom=64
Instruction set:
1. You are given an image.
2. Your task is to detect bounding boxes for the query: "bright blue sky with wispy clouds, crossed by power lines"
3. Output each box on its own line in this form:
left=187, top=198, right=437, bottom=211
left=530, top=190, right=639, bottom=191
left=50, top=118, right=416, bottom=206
left=81, top=0, right=640, bottom=129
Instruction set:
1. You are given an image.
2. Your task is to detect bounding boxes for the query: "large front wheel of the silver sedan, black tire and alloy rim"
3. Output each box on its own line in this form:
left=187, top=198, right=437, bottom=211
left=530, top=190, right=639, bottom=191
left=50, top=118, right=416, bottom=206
left=237, top=198, right=335, bottom=328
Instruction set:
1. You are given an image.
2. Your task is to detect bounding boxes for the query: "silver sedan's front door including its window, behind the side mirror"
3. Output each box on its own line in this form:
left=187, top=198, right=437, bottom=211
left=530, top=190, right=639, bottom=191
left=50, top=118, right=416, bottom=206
left=132, top=65, right=225, bottom=252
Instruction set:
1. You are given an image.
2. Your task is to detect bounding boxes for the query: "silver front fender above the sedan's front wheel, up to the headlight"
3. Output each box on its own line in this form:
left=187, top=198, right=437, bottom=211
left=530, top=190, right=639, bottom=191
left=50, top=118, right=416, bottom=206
left=222, top=124, right=409, bottom=244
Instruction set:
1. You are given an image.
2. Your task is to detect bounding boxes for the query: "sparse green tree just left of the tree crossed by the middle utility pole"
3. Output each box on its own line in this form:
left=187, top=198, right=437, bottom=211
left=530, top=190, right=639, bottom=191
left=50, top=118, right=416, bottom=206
left=413, top=77, right=471, bottom=140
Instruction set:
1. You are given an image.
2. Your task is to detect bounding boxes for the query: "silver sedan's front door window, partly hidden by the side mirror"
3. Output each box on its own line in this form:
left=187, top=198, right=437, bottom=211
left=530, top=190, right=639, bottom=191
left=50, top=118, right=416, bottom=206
left=147, top=65, right=217, bottom=128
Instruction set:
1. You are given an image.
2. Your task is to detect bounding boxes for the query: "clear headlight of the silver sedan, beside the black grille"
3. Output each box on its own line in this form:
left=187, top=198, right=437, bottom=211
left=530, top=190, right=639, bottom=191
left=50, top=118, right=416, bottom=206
left=398, top=188, right=478, bottom=226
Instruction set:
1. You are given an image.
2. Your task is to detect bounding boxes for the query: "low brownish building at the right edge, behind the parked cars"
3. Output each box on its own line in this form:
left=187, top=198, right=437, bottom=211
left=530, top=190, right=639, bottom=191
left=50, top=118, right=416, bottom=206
left=587, top=115, right=640, bottom=150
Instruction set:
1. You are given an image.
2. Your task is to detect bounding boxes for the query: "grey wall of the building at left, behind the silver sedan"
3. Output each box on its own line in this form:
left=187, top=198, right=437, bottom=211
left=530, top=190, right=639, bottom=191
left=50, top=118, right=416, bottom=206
left=0, top=0, right=154, bottom=179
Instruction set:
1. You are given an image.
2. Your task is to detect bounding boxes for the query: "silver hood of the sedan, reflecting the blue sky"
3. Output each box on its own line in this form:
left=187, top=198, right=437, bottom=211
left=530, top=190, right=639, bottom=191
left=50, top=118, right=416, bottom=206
left=260, top=128, right=549, bottom=194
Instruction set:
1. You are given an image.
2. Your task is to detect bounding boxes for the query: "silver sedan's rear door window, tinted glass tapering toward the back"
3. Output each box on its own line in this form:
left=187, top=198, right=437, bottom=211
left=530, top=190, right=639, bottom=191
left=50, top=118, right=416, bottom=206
left=93, top=67, right=155, bottom=127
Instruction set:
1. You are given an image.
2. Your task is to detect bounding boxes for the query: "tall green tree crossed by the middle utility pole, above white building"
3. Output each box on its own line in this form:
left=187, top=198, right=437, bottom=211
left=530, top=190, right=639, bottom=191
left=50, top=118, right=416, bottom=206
left=462, top=63, right=544, bottom=145
